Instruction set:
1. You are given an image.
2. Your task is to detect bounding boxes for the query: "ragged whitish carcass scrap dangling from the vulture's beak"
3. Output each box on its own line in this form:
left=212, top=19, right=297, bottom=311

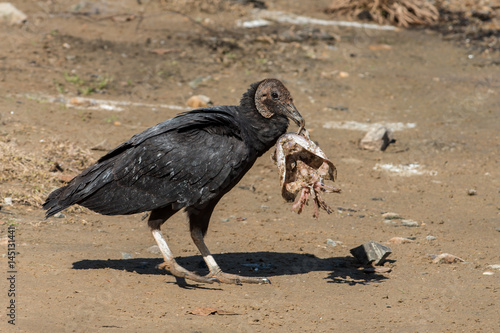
left=272, top=131, right=340, bottom=218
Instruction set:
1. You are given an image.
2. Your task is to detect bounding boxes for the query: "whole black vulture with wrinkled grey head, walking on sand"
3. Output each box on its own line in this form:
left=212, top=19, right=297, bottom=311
left=43, top=79, right=305, bottom=284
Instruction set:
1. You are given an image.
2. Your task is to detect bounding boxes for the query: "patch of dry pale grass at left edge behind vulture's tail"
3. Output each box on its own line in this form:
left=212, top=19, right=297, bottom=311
left=0, top=137, right=94, bottom=207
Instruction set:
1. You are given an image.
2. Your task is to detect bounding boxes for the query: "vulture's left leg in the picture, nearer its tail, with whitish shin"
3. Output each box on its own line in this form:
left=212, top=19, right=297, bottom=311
left=148, top=207, right=216, bottom=283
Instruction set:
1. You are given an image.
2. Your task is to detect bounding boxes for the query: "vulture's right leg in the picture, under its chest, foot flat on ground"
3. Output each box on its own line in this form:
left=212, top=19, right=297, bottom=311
left=188, top=204, right=271, bottom=284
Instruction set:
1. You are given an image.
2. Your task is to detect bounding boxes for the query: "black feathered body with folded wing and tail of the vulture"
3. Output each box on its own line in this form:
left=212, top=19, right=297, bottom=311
left=44, top=107, right=250, bottom=216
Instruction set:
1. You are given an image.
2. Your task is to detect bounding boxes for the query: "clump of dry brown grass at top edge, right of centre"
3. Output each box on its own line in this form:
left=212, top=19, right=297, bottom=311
left=325, top=0, right=439, bottom=27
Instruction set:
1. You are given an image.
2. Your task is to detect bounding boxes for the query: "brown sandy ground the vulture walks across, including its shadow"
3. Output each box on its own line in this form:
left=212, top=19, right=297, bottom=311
left=0, top=1, right=500, bottom=332
